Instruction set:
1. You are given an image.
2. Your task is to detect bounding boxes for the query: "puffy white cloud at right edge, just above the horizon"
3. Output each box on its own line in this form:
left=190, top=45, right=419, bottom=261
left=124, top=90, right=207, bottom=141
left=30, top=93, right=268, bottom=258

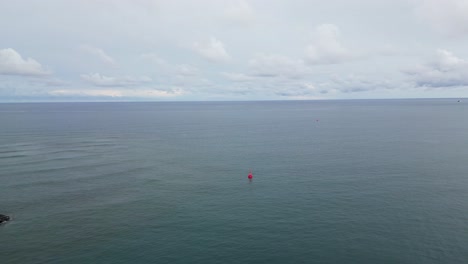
left=403, top=49, right=468, bottom=88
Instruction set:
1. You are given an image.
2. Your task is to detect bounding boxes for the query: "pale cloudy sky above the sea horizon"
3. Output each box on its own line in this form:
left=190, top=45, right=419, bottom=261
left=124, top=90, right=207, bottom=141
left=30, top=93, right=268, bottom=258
left=0, top=0, right=468, bottom=102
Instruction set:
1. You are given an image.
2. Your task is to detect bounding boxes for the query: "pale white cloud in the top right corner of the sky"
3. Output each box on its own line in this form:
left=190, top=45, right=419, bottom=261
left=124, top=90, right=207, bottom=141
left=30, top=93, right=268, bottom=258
left=414, top=0, right=468, bottom=36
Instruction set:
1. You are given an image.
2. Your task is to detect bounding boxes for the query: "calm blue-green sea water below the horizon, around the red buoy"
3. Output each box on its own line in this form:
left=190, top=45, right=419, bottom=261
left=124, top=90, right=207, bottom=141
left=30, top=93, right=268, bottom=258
left=0, top=99, right=468, bottom=264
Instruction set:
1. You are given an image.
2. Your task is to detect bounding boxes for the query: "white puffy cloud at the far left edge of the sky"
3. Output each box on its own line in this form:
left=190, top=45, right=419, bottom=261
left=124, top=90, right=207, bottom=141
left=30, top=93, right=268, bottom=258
left=0, top=49, right=50, bottom=76
